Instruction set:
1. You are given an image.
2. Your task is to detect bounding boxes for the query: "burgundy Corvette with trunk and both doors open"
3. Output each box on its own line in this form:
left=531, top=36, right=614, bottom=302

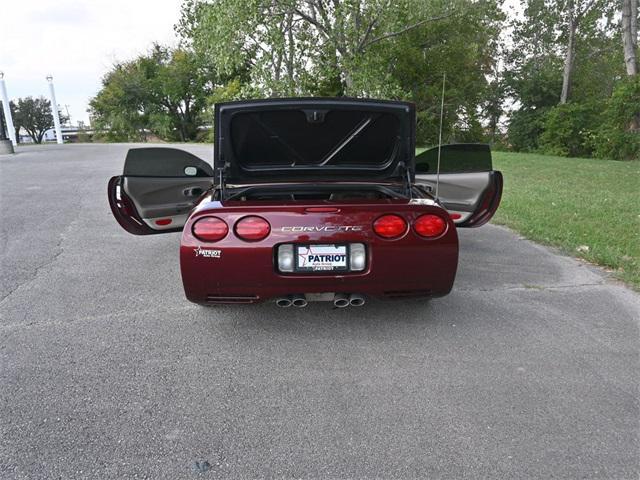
left=108, top=98, right=502, bottom=307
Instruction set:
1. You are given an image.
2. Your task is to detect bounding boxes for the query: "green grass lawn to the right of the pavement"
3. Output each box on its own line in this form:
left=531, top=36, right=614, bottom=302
left=493, top=152, right=640, bottom=290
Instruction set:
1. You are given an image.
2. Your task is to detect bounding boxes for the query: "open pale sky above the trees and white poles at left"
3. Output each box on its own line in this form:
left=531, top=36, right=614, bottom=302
left=0, top=0, right=182, bottom=124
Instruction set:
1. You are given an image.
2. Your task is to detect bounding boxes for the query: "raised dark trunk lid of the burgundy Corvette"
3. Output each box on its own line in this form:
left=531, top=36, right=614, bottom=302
left=214, top=98, right=415, bottom=184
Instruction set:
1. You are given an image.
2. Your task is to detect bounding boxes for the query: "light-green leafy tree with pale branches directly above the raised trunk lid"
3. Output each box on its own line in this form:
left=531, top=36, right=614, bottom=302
left=178, top=0, right=458, bottom=95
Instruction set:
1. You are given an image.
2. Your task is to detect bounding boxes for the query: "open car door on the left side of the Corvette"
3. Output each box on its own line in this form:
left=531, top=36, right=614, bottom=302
left=108, top=147, right=214, bottom=235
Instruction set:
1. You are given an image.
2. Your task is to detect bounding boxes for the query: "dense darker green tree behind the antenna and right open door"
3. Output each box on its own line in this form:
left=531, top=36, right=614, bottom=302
left=354, top=1, right=504, bottom=145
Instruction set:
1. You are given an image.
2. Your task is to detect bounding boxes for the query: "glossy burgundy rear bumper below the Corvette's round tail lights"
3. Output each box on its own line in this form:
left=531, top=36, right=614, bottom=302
left=180, top=226, right=458, bottom=304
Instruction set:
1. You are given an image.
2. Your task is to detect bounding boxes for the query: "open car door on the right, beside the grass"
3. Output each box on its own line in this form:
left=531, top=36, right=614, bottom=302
left=415, top=143, right=502, bottom=227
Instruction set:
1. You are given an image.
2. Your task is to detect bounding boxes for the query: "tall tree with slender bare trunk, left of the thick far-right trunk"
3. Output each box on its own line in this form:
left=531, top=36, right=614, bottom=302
left=505, top=0, right=622, bottom=152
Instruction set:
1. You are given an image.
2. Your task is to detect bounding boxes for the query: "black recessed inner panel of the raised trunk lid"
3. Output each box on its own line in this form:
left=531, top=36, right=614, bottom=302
left=230, top=109, right=401, bottom=169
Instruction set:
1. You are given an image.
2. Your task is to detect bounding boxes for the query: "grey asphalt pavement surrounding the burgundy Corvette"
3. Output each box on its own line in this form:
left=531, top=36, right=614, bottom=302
left=0, top=145, right=640, bottom=479
